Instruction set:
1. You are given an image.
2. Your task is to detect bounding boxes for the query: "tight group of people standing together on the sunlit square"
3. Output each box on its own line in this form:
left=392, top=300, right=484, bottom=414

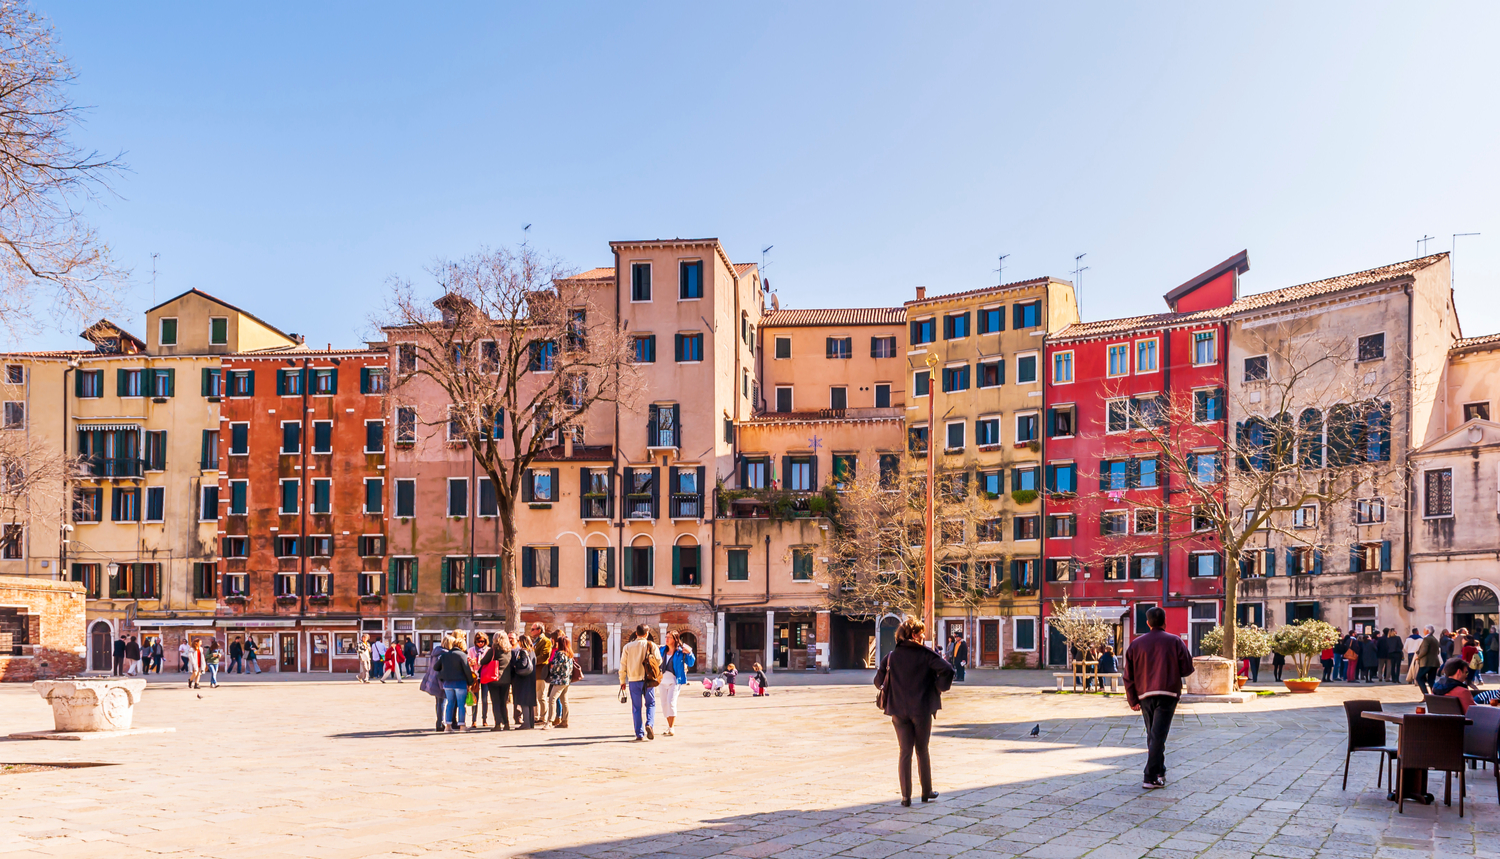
left=426, top=624, right=582, bottom=733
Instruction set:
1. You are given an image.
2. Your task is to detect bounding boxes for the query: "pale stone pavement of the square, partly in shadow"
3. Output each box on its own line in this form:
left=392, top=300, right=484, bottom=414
left=0, top=672, right=1500, bottom=859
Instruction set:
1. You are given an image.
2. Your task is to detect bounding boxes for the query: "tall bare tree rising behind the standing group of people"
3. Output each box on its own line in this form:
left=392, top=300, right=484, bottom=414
left=384, top=244, right=639, bottom=631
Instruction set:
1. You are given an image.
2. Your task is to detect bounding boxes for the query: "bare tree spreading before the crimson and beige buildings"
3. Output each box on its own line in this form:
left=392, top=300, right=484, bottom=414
left=1082, top=333, right=1412, bottom=654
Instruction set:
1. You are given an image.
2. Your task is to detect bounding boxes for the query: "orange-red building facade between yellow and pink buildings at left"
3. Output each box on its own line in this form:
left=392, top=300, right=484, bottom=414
left=219, top=351, right=389, bottom=672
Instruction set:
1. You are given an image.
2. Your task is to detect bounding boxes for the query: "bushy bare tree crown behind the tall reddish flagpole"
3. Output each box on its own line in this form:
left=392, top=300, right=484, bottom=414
left=821, top=456, right=1005, bottom=623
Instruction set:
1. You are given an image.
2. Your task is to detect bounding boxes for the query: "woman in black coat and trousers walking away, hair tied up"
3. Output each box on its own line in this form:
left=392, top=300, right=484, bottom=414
left=875, top=618, right=953, bottom=805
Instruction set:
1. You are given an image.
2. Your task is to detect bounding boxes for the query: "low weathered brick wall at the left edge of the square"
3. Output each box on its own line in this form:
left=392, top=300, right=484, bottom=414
left=0, top=576, right=86, bottom=682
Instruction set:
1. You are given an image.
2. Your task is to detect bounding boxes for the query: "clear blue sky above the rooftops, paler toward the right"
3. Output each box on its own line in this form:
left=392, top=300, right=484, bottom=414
left=26, top=1, right=1500, bottom=346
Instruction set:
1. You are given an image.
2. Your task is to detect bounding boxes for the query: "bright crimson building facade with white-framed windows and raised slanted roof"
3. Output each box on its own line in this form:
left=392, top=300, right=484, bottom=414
left=1043, top=253, right=1250, bottom=664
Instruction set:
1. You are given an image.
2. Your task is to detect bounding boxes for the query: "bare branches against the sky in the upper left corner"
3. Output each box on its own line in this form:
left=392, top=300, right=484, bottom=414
left=0, top=0, right=125, bottom=336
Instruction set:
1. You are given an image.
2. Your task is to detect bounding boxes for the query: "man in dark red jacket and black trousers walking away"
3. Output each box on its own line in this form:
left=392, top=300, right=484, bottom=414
left=1124, top=606, right=1193, bottom=789
